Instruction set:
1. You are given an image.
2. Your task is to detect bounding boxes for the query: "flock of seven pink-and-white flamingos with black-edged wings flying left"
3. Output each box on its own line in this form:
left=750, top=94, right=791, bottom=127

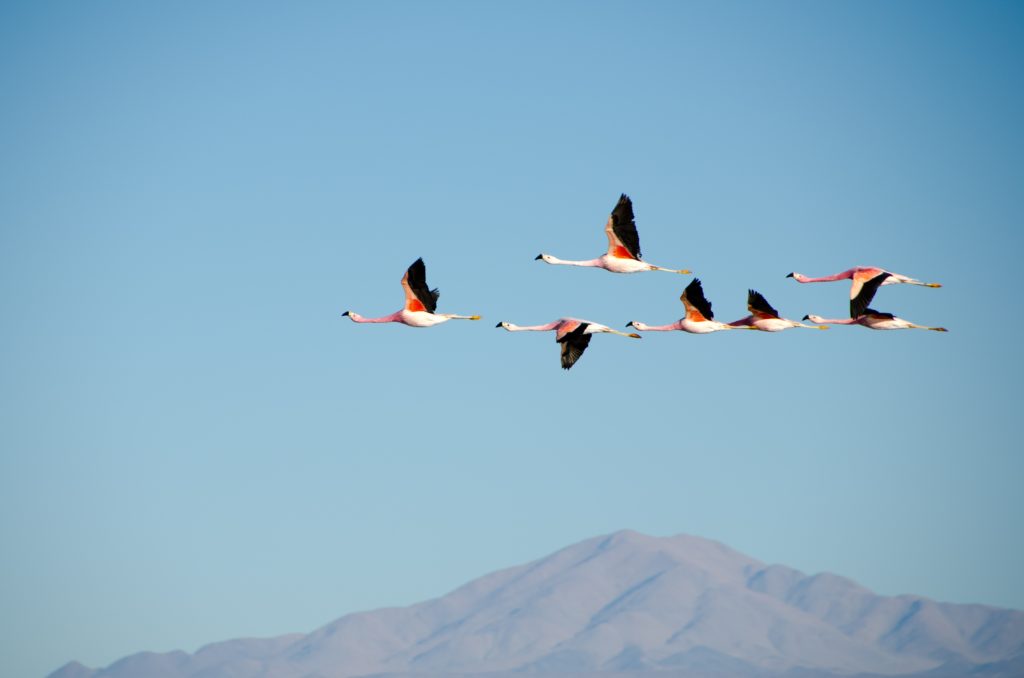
left=342, top=194, right=947, bottom=370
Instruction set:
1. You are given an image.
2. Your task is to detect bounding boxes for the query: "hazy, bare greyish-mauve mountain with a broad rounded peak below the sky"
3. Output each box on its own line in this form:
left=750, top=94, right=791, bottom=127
left=49, top=531, right=1024, bottom=678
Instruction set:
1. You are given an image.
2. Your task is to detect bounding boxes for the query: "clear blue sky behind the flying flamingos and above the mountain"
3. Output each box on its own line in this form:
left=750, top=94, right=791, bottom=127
left=0, top=2, right=1024, bottom=676
